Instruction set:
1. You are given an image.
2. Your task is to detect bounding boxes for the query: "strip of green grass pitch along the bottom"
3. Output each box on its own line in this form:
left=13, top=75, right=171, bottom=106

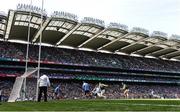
left=0, top=100, right=180, bottom=111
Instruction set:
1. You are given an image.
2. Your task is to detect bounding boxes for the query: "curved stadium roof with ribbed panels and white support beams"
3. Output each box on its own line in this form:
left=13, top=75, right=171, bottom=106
left=0, top=4, right=180, bottom=60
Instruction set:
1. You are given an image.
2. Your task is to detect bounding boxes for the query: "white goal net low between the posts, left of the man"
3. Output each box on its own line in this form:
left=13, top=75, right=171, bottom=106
left=8, top=68, right=37, bottom=102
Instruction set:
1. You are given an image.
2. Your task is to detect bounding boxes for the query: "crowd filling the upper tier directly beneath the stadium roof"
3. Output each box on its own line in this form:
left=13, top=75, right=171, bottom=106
left=0, top=42, right=180, bottom=72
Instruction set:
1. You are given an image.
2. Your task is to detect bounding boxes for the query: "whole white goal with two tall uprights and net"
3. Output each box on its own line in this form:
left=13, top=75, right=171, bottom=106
left=8, top=0, right=44, bottom=102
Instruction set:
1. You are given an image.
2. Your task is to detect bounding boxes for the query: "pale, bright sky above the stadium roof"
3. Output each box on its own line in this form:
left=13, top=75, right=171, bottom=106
left=0, top=0, right=180, bottom=36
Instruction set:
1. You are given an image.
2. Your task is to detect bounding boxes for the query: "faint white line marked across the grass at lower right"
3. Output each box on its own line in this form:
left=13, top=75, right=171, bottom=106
left=105, top=103, right=180, bottom=107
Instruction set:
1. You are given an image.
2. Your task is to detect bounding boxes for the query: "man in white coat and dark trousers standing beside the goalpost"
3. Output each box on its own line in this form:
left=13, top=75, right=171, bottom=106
left=38, top=75, right=50, bottom=102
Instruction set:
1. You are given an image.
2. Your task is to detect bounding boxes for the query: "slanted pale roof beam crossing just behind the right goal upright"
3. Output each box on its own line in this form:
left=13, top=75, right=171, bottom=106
left=32, top=17, right=52, bottom=42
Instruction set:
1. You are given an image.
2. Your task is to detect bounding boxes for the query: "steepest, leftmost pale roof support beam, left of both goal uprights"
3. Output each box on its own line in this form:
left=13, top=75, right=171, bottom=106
left=5, top=10, right=15, bottom=40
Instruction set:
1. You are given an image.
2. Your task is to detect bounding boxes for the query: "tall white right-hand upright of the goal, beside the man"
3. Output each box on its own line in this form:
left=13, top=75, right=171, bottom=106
left=36, top=0, right=44, bottom=100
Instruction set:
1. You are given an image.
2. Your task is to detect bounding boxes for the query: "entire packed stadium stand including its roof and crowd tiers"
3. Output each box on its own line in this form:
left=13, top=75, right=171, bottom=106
left=0, top=4, right=180, bottom=101
